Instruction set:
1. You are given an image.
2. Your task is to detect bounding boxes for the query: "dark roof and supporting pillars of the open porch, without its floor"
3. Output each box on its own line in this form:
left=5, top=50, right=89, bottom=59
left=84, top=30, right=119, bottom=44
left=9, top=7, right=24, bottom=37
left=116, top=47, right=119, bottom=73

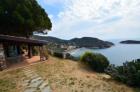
left=0, top=35, right=47, bottom=67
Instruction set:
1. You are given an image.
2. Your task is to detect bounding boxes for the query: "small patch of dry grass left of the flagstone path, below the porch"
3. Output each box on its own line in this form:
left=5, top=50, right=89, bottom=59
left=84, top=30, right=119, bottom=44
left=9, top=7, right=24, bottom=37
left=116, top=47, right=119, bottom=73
left=0, top=69, right=24, bottom=92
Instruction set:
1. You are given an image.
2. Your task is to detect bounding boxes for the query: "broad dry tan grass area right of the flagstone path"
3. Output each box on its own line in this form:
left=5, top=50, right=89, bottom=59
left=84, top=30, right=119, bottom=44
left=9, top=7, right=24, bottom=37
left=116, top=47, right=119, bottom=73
left=30, top=57, right=139, bottom=92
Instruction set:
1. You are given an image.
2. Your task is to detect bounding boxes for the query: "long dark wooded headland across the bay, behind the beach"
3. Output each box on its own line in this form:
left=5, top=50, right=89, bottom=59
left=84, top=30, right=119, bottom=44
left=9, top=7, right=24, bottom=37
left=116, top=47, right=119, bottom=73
left=33, top=36, right=114, bottom=48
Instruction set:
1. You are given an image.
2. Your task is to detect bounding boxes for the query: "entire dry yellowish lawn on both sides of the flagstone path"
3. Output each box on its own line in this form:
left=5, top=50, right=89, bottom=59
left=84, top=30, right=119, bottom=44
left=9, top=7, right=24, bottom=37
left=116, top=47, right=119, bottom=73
left=0, top=57, right=140, bottom=92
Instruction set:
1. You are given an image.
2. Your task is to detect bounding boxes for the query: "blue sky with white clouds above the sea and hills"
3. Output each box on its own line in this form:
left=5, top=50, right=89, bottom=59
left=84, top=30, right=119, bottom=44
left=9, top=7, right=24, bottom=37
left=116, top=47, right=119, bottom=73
left=37, top=0, right=140, bottom=40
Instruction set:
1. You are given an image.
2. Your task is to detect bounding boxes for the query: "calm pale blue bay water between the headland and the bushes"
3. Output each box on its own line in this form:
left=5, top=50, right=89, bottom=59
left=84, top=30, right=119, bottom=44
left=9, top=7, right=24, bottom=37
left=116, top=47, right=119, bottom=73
left=69, top=44, right=140, bottom=65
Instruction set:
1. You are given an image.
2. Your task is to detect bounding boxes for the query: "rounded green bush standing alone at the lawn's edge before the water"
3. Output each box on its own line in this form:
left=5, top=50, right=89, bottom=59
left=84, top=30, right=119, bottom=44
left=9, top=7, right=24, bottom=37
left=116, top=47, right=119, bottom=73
left=80, top=52, right=109, bottom=72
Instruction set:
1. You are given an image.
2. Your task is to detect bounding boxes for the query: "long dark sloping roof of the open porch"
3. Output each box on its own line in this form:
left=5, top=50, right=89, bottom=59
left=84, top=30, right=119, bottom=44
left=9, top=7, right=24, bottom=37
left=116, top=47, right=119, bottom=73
left=0, top=35, right=47, bottom=45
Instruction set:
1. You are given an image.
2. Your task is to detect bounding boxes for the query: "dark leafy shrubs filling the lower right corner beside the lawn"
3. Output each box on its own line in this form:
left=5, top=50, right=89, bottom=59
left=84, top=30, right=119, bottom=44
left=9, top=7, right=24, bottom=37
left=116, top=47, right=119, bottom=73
left=106, top=59, right=140, bottom=87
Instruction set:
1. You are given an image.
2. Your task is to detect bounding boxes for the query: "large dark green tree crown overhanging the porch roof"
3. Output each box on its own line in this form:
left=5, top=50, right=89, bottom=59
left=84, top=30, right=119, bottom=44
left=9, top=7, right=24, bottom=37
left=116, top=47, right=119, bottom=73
left=0, top=0, right=52, bottom=37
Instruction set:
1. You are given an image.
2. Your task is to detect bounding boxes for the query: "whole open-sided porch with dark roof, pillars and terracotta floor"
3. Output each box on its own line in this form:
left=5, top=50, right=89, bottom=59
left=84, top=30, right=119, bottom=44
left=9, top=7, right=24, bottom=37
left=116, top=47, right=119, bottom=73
left=0, top=35, right=47, bottom=70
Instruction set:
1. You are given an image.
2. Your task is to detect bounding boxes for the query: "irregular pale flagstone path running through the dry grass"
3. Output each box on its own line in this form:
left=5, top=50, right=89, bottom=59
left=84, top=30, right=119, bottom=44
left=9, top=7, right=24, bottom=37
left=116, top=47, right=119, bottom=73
left=22, top=68, right=51, bottom=92
